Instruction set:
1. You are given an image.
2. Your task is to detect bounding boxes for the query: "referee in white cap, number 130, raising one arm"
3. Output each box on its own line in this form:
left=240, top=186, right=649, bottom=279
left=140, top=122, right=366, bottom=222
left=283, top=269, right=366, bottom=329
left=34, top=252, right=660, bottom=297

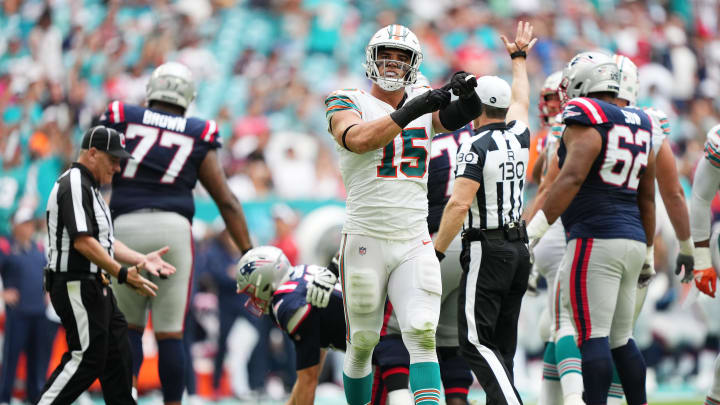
left=435, top=22, right=535, bottom=405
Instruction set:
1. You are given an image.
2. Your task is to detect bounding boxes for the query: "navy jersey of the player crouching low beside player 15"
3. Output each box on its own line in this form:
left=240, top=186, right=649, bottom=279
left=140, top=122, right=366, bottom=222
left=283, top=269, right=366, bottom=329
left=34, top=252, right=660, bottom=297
left=270, top=265, right=345, bottom=370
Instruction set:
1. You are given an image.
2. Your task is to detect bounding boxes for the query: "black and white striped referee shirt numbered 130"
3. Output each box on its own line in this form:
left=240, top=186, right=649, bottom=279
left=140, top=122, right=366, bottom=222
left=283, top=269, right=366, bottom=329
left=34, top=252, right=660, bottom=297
left=455, top=121, right=530, bottom=229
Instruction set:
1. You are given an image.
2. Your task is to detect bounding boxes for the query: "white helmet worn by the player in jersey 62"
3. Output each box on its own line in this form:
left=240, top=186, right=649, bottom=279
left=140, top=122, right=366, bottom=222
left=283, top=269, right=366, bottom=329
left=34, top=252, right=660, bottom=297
left=560, top=52, right=620, bottom=103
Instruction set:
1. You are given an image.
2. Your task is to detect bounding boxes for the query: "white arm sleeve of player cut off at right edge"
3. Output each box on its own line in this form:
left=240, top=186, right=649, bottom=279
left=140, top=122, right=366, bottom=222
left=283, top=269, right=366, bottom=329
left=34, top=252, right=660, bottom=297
left=690, top=158, right=720, bottom=242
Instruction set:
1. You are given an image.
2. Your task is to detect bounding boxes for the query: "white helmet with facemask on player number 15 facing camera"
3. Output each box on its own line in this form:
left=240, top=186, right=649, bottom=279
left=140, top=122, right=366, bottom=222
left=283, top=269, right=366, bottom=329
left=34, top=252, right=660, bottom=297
left=364, top=24, right=422, bottom=91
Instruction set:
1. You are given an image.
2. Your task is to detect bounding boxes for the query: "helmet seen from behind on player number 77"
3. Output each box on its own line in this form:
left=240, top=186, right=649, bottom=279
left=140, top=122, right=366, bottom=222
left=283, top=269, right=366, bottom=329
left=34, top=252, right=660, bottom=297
left=145, top=62, right=195, bottom=109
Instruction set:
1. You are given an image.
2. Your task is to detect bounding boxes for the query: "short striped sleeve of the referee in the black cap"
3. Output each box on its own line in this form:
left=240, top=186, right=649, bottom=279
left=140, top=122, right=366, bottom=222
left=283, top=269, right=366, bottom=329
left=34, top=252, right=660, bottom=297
left=58, top=169, right=94, bottom=240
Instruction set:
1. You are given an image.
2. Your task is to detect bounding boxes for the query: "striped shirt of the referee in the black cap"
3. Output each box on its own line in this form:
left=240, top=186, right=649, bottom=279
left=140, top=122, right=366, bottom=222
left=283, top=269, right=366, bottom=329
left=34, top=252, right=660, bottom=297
left=46, top=163, right=115, bottom=273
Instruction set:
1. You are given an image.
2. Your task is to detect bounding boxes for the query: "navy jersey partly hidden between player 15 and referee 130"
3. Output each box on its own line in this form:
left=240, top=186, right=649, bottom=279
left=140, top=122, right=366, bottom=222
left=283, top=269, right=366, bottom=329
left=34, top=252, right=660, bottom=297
left=428, top=124, right=473, bottom=233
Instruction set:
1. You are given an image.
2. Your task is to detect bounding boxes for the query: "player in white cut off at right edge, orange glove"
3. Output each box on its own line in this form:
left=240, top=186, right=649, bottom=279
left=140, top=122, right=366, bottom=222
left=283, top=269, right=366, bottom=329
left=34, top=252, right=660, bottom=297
left=690, top=124, right=720, bottom=405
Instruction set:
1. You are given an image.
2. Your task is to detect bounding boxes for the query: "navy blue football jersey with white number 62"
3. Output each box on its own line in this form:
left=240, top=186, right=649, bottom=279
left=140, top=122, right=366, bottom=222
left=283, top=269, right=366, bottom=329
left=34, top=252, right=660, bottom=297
left=558, top=98, right=652, bottom=243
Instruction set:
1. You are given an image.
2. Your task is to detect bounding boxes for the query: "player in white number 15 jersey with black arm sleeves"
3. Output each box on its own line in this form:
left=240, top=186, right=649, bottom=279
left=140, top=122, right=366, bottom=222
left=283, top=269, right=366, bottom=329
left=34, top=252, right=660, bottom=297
left=325, top=24, right=480, bottom=405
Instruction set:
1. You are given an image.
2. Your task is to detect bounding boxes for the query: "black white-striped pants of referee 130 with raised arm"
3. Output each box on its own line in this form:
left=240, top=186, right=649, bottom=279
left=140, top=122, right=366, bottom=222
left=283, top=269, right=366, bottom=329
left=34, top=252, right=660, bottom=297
left=458, top=236, right=530, bottom=405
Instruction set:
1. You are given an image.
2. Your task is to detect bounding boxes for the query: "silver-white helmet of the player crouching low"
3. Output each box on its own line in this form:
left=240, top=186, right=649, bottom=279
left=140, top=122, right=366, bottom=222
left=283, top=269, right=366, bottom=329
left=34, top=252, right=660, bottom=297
left=235, top=246, right=290, bottom=316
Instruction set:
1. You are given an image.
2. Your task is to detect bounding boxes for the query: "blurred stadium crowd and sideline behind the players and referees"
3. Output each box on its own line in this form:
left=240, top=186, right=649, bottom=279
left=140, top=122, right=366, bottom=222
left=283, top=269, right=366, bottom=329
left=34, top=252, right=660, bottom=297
left=0, top=0, right=720, bottom=402
